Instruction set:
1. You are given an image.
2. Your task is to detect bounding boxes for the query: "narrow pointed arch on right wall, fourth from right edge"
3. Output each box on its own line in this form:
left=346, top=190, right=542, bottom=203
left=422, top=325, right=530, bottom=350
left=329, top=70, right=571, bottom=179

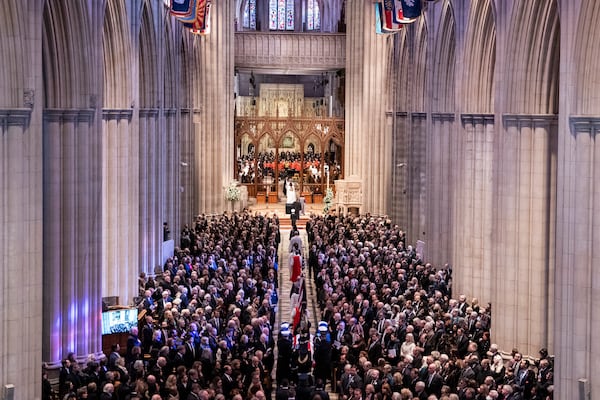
left=432, top=0, right=456, bottom=112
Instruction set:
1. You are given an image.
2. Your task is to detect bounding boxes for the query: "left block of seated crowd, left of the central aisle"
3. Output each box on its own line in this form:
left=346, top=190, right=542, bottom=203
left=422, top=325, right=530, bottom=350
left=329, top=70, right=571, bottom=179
left=51, top=211, right=280, bottom=400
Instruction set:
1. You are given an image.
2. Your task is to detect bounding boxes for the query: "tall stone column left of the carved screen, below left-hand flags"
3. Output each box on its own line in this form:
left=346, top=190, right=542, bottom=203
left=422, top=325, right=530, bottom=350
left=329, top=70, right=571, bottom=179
left=194, top=1, right=235, bottom=213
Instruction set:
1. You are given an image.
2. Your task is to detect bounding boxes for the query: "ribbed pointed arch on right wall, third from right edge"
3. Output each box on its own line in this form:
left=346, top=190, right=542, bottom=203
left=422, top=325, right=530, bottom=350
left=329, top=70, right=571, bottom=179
left=463, top=0, right=496, bottom=113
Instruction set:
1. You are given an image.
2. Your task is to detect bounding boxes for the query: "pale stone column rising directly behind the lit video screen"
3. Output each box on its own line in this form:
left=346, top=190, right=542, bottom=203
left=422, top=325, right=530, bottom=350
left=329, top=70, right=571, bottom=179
left=102, top=109, right=140, bottom=304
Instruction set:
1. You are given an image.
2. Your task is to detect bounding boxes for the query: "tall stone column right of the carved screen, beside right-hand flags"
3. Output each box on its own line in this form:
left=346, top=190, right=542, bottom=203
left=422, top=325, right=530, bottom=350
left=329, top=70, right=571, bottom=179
left=344, top=0, right=393, bottom=214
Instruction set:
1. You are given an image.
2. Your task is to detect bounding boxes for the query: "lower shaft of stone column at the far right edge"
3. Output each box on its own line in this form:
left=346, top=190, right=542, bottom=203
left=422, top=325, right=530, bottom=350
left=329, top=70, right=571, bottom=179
left=554, top=116, right=600, bottom=399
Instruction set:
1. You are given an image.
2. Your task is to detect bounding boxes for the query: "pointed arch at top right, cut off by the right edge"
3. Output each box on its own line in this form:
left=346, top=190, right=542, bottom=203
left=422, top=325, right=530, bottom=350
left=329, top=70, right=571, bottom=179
left=574, top=0, right=600, bottom=115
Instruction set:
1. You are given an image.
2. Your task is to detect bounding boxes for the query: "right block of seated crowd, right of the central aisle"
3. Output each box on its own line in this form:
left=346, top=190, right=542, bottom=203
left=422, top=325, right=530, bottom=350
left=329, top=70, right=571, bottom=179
left=297, top=215, right=553, bottom=400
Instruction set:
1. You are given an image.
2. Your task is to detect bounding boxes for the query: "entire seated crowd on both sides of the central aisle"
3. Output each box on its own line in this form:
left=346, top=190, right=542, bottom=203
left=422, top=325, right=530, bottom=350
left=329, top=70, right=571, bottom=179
left=51, top=212, right=553, bottom=400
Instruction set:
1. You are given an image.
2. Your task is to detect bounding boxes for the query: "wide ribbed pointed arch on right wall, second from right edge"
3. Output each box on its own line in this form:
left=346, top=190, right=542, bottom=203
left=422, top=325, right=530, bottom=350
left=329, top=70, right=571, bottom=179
left=507, top=0, right=560, bottom=114
